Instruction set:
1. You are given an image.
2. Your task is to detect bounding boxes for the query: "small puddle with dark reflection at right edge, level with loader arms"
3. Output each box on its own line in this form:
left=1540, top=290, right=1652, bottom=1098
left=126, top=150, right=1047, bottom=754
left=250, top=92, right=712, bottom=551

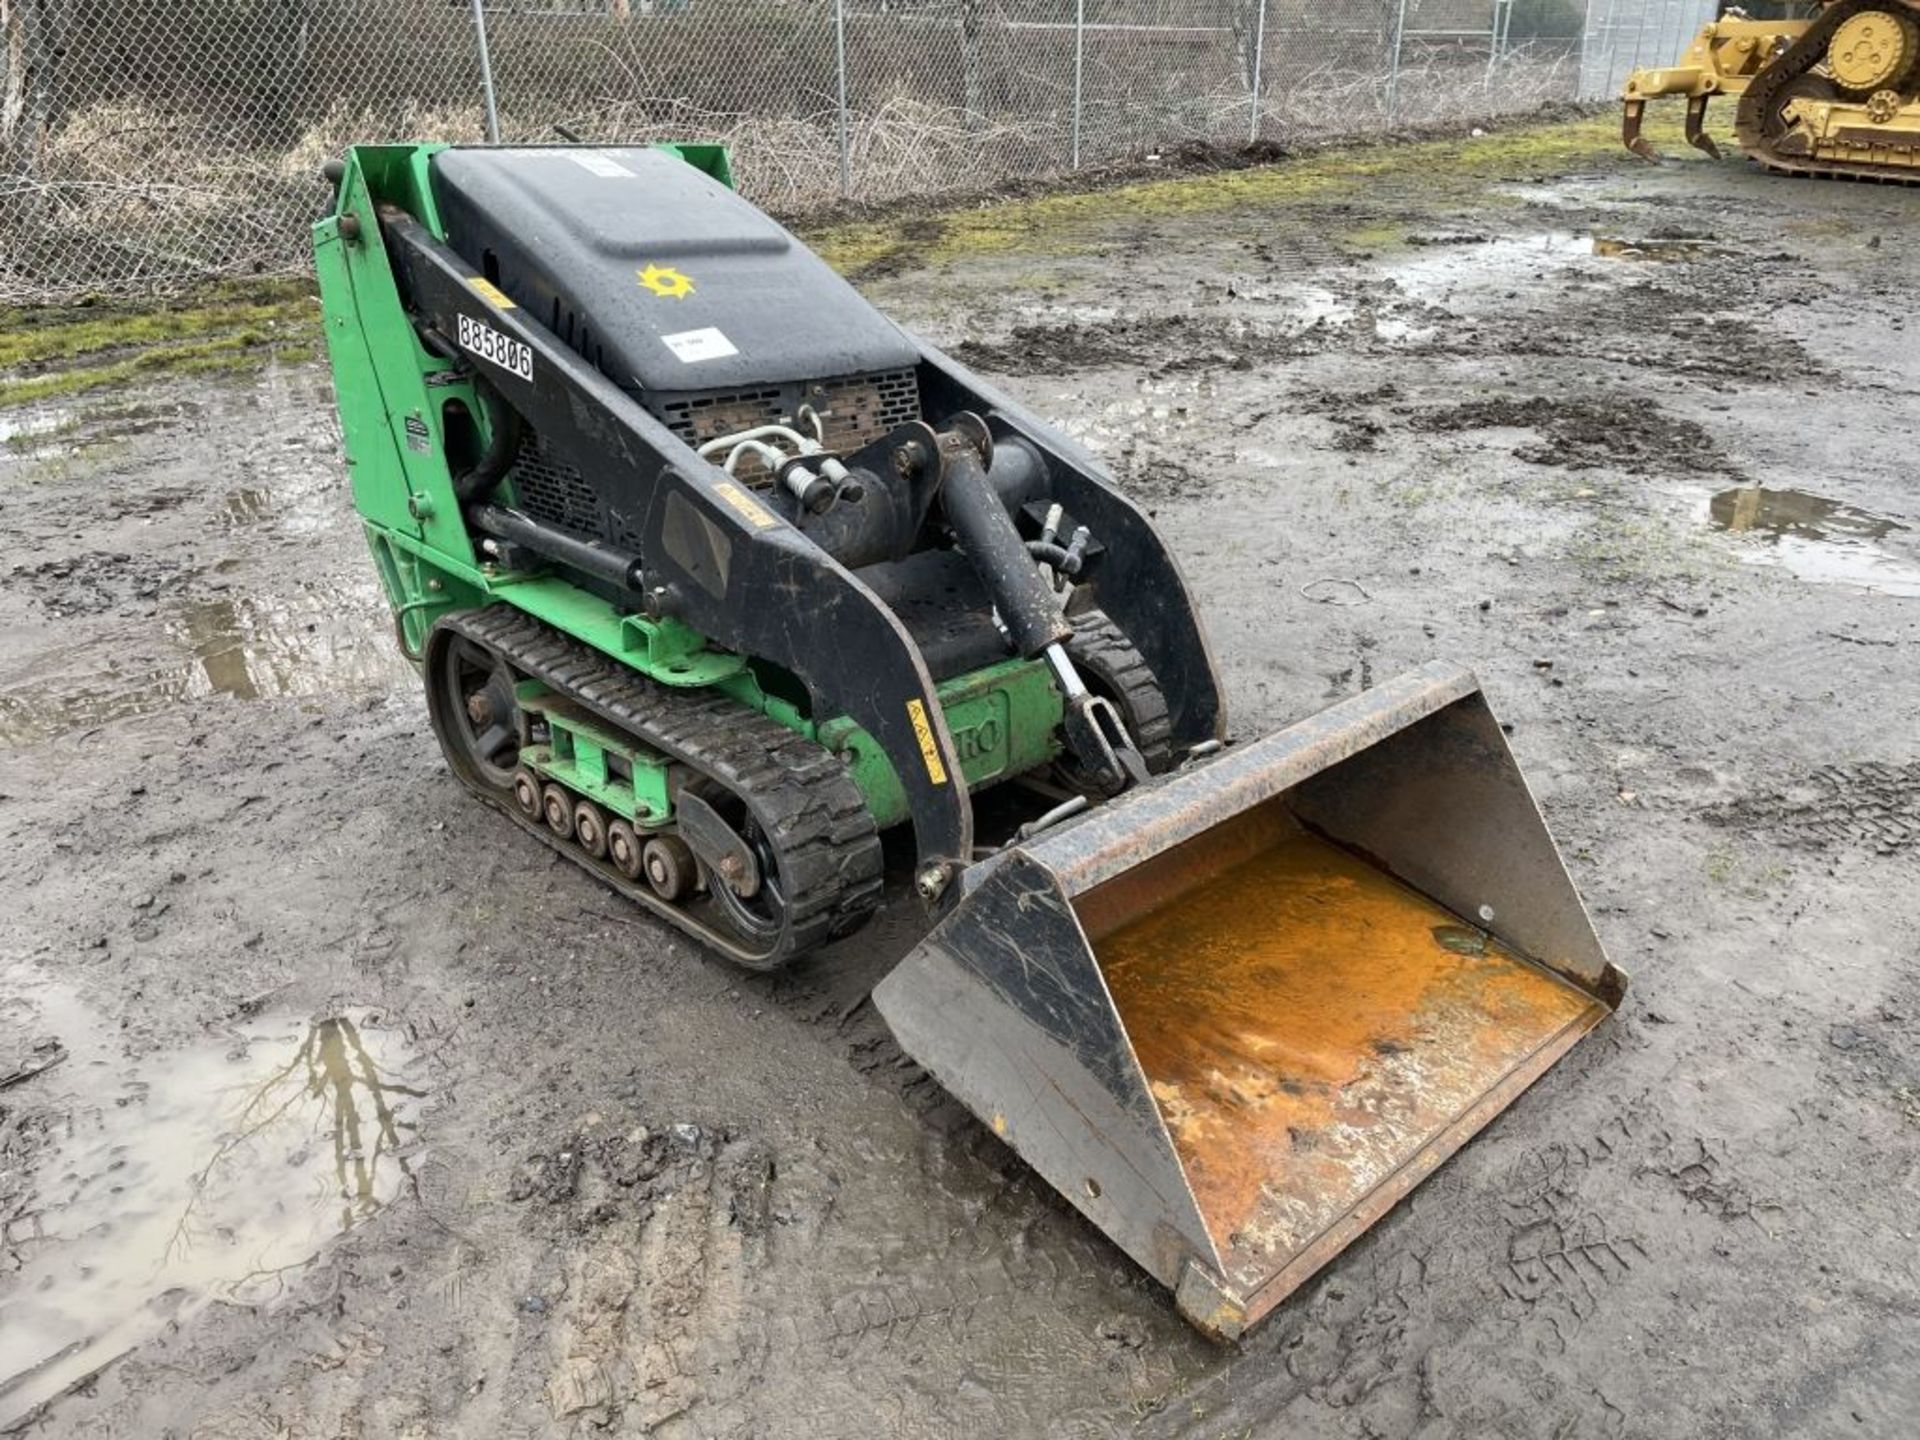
left=1703, top=486, right=1920, bottom=597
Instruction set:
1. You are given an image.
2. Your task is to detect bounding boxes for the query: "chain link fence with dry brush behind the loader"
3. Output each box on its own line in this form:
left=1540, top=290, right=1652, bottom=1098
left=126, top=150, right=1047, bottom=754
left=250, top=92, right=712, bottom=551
left=0, top=0, right=1707, bottom=301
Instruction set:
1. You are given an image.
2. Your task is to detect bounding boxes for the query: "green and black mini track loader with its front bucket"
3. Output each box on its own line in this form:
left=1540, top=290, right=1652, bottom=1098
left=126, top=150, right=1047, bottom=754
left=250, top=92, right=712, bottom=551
left=315, top=146, right=1624, bottom=1336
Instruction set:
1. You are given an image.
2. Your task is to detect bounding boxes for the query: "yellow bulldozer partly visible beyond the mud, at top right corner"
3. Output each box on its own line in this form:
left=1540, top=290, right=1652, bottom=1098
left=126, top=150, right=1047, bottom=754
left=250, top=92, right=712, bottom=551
left=1620, top=0, right=1920, bottom=182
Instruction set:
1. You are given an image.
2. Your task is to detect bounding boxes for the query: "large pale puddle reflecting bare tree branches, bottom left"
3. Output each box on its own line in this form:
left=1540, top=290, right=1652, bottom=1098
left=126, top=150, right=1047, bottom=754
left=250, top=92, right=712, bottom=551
left=0, top=966, right=426, bottom=1425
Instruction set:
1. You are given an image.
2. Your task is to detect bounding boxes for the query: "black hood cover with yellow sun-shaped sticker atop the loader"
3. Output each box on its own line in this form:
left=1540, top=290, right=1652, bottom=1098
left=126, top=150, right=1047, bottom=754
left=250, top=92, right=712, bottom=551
left=432, top=146, right=920, bottom=394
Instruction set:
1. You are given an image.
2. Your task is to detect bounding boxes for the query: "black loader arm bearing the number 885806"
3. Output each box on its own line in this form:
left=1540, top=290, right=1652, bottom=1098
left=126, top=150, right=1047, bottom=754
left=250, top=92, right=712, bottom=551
left=380, top=207, right=973, bottom=899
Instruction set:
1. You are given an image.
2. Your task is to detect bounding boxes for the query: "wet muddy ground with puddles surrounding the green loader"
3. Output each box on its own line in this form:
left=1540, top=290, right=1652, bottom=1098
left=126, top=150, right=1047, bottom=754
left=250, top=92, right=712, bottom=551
left=0, top=123, right=1920, bottom=1440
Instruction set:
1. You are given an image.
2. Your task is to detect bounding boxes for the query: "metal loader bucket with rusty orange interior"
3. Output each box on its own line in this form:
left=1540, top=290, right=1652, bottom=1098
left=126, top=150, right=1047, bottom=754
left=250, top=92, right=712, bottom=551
left=874, top=664, right=1626, bottom=1338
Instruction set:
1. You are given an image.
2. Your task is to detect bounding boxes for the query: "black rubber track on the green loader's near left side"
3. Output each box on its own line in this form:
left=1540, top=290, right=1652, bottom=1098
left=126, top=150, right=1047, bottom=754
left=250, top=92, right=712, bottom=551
left=442, top=605, right=883, bottom=970
